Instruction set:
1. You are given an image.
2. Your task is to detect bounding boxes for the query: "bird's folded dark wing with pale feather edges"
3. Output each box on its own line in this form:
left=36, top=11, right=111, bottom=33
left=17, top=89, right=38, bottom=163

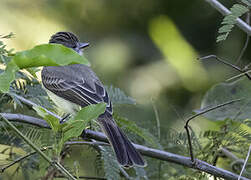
left=42, top=76, right=112, bottom=114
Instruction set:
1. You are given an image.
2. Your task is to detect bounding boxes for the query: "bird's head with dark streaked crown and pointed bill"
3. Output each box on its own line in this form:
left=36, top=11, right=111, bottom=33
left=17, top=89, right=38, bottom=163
left=49, top=32, right=89, bottom=55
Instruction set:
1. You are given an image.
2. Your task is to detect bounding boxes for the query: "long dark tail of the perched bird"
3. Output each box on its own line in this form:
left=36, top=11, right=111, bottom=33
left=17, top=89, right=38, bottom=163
left=98, top=116, right=145, bottom=167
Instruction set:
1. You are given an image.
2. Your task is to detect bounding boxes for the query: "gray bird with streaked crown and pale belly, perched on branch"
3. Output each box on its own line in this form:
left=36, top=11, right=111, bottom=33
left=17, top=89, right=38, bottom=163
left=41, top=32, right=146, bottom=167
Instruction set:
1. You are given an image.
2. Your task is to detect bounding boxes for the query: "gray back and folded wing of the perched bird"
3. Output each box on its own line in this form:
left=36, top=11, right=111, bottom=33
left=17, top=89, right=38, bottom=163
left=42, top=64, right=112, bottom=115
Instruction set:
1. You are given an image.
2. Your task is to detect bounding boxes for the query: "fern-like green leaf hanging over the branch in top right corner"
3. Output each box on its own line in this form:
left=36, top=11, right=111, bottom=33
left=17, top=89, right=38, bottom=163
left=216, top=3, right=250, bottom=42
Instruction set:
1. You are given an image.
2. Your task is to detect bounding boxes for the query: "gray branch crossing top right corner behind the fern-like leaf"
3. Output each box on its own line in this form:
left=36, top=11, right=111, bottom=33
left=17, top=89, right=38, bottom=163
left=205, top=0, right=251, bottom=36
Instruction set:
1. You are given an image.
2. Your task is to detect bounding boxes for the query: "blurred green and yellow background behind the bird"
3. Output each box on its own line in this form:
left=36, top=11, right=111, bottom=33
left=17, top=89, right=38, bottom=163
left=0, top=0, right=249, bottom=179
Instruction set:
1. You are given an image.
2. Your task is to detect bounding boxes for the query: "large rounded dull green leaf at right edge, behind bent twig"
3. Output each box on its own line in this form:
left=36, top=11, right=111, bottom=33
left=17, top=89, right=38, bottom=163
left=201, top=78, right=251, bottom=120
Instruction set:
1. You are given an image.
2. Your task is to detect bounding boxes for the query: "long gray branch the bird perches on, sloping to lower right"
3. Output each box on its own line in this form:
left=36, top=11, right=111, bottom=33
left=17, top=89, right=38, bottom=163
left=0, top=113, right=248, bottom=180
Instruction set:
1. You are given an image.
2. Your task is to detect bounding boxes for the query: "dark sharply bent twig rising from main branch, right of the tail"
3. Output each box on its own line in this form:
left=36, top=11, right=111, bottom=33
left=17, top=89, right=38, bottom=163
left=184, top=99, right=242, bottom=163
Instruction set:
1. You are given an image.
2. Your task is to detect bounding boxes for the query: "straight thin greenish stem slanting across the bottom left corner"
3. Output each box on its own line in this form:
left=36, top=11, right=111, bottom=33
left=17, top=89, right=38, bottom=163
left=0, top=114, right=75, bottom=180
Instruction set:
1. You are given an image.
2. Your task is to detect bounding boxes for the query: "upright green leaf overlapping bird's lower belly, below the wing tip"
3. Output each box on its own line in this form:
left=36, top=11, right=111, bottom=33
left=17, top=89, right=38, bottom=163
left=63, top=103, right=106, bottom=142
